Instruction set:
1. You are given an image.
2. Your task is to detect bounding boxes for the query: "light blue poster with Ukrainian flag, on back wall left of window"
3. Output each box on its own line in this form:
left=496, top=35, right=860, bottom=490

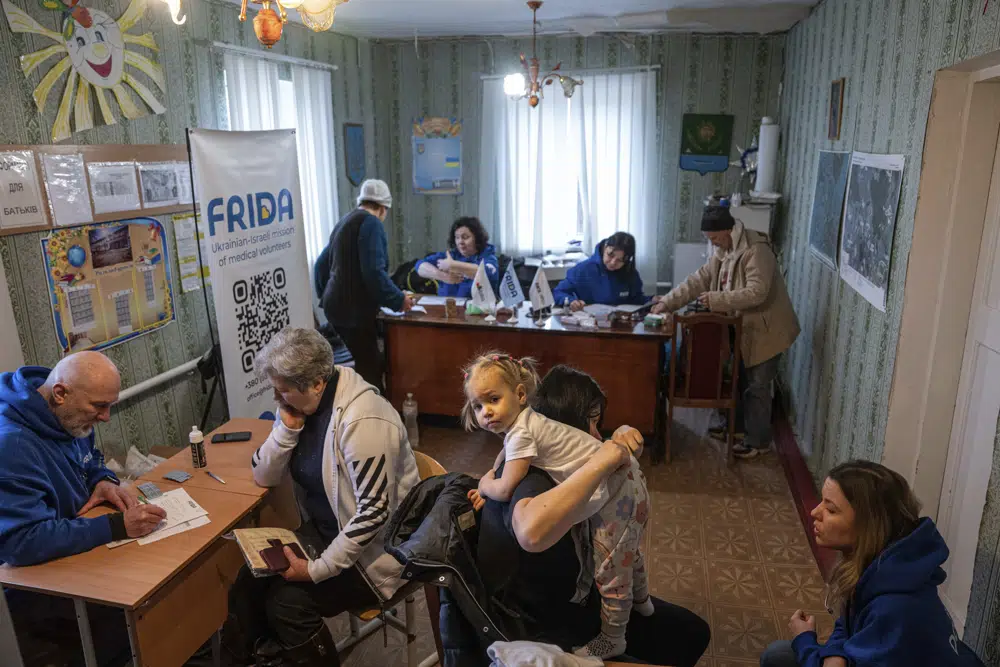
left=413, top=116, right=462, bottom=195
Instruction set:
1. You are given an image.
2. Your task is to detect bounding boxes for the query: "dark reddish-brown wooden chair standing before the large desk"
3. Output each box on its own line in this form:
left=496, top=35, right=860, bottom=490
left=661, top=313, right=743, bottom=463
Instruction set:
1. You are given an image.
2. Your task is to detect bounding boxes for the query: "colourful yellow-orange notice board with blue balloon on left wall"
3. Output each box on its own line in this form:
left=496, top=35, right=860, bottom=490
left=42, top=218, right=174, bottom=355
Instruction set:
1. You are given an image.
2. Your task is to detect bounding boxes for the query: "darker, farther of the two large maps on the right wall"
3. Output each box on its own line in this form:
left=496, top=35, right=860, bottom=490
left=809, top=151, right=851, bottom=269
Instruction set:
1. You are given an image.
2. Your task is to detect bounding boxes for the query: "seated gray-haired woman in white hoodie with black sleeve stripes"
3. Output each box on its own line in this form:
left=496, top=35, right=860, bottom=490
left=223, top=328, right=419, bottom=667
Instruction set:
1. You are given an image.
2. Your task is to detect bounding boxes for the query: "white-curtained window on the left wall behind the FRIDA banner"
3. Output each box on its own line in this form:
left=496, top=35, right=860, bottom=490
left=222, top=51, right=340, bottom=266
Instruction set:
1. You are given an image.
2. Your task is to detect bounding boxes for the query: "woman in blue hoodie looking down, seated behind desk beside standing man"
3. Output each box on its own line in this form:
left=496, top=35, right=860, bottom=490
left=552, top=232, right=649, bottom=310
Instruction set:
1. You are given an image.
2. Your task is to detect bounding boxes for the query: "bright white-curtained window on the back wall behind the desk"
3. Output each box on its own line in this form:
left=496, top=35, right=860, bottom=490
left=479, top=70, right=660, bottom=290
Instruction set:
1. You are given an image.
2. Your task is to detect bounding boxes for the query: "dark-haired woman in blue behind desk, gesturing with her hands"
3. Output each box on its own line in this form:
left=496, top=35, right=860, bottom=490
left=416, top=217, right=500, bottom=298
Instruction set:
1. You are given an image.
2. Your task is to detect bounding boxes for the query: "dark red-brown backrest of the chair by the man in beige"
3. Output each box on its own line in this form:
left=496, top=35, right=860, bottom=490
left=670, top=313, right=743, bottom=407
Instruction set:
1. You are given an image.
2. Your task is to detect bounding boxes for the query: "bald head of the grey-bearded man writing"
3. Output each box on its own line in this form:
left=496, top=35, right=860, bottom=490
left=38, top=351, right=121, bottom=438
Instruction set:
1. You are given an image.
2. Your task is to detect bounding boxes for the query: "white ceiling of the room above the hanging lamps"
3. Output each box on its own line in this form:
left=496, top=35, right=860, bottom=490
left=333, top=0, right=819, bottom=38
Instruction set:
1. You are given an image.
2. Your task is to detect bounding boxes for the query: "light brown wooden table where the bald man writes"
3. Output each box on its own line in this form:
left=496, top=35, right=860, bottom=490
left=0, top=419, right=272, bottom=667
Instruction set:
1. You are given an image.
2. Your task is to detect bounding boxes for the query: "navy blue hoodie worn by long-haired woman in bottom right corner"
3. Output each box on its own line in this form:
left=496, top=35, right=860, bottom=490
left=792, top=518, right=982, bottom=667
